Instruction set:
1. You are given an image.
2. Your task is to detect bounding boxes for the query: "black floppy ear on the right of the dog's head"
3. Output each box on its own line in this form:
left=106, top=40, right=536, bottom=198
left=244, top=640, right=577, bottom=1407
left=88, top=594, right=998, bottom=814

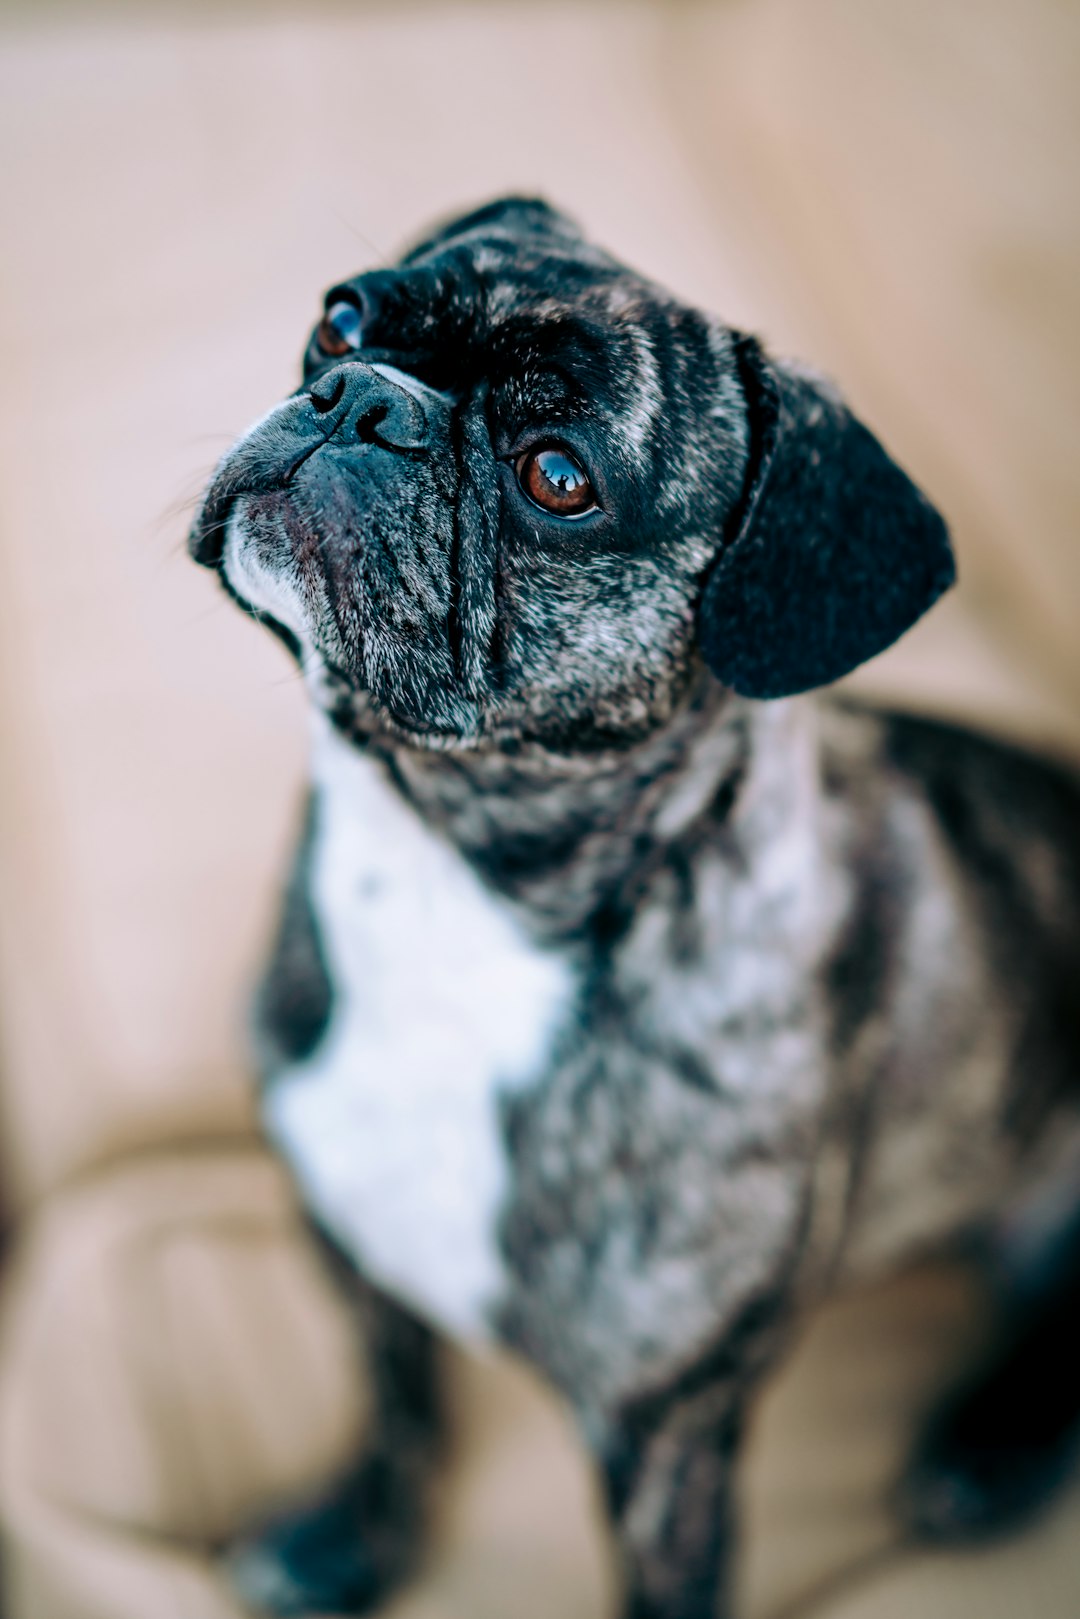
left=698, top=337, right=955, bottom=698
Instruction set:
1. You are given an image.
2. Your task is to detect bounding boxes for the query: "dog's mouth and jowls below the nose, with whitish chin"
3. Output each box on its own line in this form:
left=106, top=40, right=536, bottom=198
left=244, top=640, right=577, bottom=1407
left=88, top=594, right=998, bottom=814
left=191, top=445, right=479, bottom=748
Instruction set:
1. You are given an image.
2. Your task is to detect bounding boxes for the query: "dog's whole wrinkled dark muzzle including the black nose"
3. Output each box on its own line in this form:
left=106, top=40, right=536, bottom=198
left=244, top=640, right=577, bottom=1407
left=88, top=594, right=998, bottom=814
left=189, top=363, right=511, bottom=746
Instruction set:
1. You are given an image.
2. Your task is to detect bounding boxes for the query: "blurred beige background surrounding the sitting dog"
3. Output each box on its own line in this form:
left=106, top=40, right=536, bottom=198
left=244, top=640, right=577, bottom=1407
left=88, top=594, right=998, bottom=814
left=0, top=0, right=1080, bottom=1619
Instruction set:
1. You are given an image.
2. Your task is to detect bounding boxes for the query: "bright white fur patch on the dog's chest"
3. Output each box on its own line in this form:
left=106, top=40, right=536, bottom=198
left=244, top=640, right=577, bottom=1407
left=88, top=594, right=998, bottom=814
left=266, top=720, right=575, bottom=1341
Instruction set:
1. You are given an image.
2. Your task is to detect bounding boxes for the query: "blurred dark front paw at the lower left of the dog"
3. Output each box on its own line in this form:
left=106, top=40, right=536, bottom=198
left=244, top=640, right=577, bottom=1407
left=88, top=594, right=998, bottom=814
left=222, top=1520, right=384, bottom=1619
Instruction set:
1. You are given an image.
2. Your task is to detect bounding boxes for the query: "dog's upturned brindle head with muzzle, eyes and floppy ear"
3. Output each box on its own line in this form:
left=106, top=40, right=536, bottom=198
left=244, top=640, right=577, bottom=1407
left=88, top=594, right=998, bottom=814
left=191, top=199, right=954, bottom=748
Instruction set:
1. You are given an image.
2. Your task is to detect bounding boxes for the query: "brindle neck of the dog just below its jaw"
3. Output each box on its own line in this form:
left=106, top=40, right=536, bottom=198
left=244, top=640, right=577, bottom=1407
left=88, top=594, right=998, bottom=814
left=317, top=670, right=816, bottom=941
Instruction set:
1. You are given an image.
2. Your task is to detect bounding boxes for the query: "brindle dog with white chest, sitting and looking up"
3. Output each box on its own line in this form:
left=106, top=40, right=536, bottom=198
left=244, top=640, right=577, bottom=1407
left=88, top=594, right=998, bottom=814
left=193, top=199, right=1080, bottom=1619
